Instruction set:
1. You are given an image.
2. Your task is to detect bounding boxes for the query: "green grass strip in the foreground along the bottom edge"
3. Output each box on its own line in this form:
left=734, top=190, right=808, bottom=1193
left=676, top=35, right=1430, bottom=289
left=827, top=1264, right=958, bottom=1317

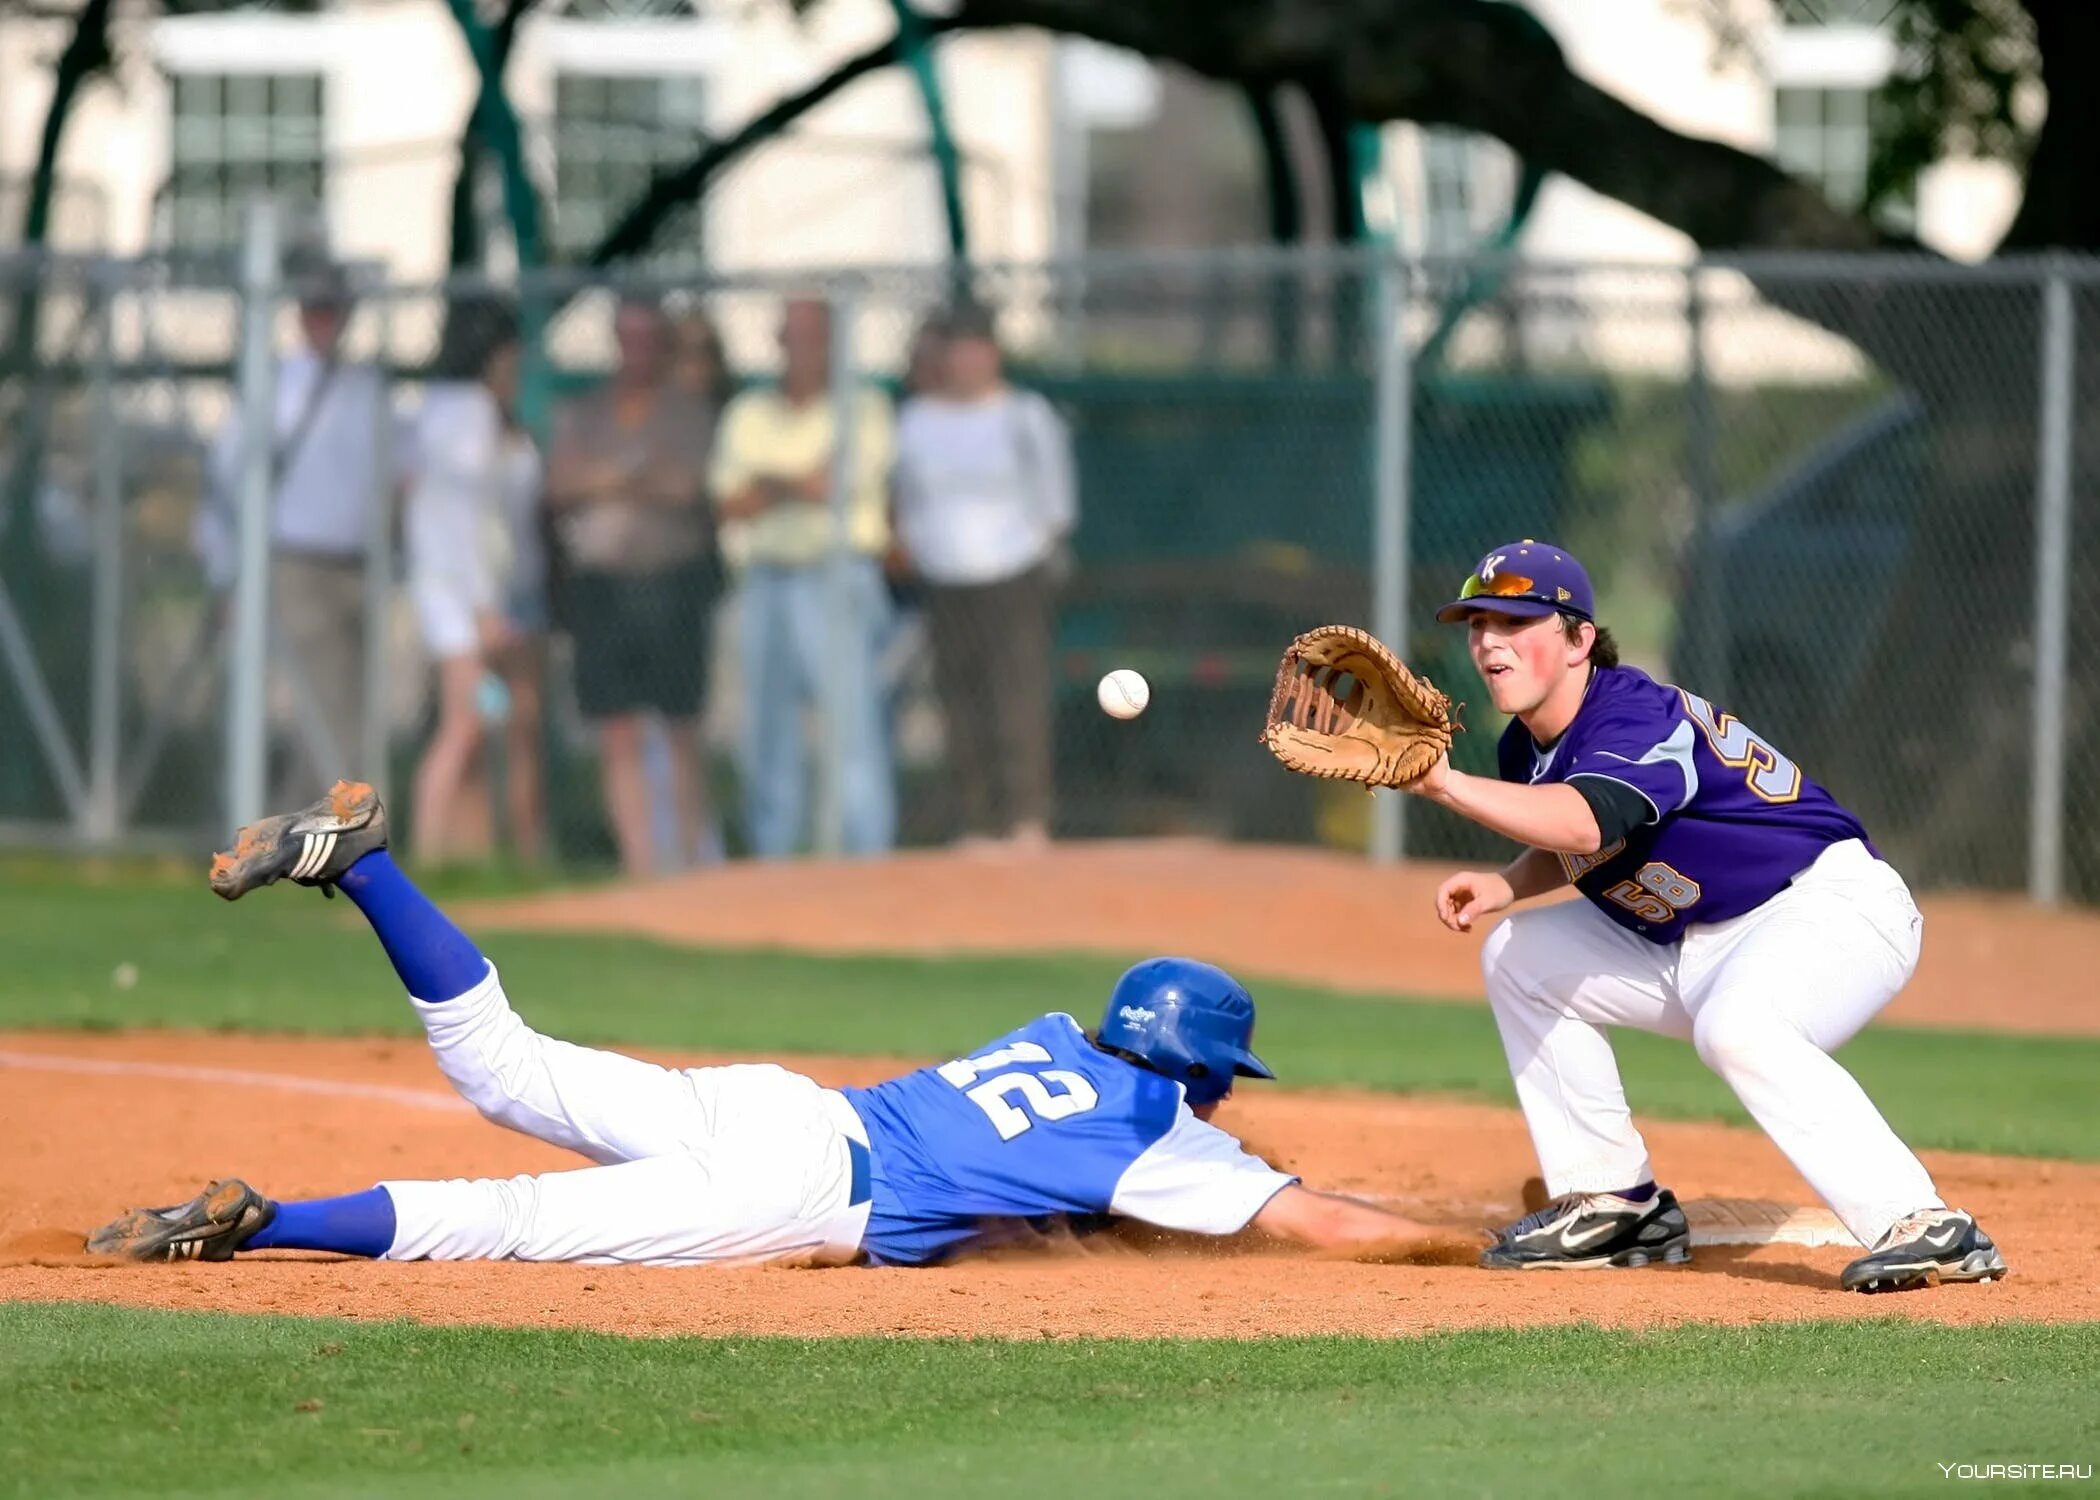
left=0, top=1273, right=2100, bottom=1500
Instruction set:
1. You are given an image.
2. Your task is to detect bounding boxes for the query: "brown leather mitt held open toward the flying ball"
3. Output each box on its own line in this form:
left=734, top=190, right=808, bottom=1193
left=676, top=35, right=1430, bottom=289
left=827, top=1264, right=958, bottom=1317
left=1262, top=626, right=1460, bottom=786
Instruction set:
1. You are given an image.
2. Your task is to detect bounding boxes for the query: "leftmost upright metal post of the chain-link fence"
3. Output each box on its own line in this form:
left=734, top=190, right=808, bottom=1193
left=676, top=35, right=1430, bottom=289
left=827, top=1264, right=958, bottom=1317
left=84, top=279, right=124, bottom=845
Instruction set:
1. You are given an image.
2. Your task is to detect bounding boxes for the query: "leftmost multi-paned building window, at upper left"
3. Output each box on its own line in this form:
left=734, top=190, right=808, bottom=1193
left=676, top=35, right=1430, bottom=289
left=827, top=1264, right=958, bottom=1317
left=168, top=71, right=328, bottom=250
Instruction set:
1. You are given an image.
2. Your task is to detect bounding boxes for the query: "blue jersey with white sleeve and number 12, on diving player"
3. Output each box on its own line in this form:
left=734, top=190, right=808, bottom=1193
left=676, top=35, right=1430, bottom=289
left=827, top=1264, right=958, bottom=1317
left=840, top=1013, right=1298, bottom=1265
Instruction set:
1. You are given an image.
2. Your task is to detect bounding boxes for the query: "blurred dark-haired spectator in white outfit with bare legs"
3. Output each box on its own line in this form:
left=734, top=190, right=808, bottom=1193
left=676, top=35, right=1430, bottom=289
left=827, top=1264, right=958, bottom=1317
left=405, top=298, right=546, bottom=861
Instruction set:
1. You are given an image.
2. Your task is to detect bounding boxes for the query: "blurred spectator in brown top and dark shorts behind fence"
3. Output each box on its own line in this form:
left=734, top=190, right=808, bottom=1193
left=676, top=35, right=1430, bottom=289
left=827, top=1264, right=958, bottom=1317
left=546, top=300, right=714, bottom=876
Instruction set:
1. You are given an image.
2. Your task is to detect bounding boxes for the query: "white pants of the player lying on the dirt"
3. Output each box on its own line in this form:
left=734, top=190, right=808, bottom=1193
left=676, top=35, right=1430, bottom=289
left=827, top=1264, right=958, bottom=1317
left=380, top=964, right=867, bottom=1265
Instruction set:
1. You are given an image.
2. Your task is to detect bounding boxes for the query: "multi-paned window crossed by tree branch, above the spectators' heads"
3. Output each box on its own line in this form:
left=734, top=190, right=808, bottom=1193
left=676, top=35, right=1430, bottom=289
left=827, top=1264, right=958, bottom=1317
left=554, top=69, right=706, bottom=258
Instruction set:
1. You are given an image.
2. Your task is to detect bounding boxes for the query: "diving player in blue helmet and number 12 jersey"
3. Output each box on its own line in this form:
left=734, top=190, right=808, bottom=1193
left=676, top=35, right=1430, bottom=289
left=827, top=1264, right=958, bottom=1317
left=88, top=782, right=1449, bottom=1265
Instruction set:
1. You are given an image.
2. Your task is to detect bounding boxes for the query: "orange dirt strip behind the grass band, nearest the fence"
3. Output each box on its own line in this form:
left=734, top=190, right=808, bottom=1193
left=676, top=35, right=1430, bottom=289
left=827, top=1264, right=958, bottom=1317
left=466, top=840, right=2100, bottom=1036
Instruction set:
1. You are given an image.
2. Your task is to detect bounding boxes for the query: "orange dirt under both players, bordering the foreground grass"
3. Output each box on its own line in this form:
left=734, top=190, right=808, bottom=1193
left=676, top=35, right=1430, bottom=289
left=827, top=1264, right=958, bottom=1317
left=0, top=1034, right=2100, bottom=1338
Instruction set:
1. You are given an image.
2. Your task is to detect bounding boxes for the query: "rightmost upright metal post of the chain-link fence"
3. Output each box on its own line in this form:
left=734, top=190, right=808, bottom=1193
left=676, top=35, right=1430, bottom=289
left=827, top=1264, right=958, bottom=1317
left=2027, top=265, right=2073, bottom=903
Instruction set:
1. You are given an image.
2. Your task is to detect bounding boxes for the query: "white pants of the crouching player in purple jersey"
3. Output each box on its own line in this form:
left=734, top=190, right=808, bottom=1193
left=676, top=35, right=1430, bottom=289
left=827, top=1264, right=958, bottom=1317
left=1481, top=838, right=1940, bottom=1246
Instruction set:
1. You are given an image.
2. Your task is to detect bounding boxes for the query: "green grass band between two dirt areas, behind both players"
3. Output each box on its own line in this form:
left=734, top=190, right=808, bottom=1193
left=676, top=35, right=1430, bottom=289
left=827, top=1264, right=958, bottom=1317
left=0, top=876, right=2100, bottom=1162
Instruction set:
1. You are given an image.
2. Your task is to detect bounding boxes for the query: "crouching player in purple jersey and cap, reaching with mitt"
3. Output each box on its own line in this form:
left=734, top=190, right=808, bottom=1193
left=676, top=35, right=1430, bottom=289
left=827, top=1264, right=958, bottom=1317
left=1264, top=540, right=2006, bottom=1292
